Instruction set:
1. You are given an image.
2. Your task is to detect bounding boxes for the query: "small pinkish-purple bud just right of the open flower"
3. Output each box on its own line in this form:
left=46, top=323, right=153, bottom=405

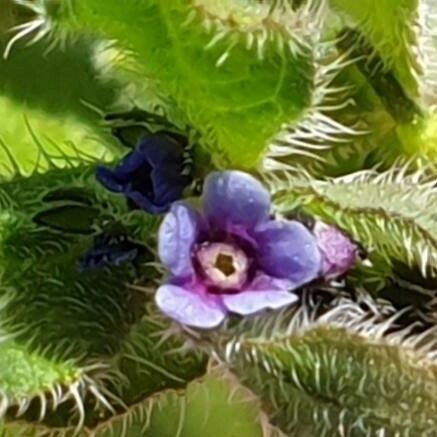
left=313, top=221, right=360, bottom=279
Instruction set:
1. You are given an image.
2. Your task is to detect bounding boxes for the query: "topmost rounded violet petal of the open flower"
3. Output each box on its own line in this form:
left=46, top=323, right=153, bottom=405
left=203, top=170, right=270, bottom=229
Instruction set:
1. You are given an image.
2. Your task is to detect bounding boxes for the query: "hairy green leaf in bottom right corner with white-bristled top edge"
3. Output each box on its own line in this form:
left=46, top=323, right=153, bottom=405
left=221, top=301, right=437, bottom=436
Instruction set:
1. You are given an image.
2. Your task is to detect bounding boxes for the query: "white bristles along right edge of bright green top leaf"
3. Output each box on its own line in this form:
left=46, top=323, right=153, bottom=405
left=260, top=24, right=367, bottom=178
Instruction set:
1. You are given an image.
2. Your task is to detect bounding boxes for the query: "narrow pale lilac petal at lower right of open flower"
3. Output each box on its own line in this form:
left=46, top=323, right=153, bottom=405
left=222, top=275, right=299, bottom=316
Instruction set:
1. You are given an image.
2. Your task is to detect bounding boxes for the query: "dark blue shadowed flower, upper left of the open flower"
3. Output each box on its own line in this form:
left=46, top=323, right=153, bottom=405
left=96, top=133, right=189, bottom=214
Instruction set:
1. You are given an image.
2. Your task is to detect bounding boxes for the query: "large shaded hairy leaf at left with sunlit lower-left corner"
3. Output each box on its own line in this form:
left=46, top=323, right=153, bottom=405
left=0, top=167, right=205, bottom=429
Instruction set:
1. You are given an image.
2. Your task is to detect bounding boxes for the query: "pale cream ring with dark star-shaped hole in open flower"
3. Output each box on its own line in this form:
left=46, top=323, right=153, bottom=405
left=196, top=243, right=249, bottom=290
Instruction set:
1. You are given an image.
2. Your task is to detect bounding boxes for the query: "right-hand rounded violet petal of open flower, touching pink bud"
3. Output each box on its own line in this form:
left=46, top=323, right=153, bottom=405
left=256, top=221, right=322, bottom=288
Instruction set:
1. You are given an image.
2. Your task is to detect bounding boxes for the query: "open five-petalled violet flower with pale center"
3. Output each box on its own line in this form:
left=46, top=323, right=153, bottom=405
left=156, top=171, right=321, bottom=328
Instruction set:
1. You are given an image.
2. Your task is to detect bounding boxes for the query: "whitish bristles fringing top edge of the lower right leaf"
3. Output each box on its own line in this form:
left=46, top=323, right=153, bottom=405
left=215, top=289, right=437, bottom=364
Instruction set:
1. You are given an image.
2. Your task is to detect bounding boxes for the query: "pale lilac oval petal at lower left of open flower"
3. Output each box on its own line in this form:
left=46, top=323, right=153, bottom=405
left=155, top=284, right=226, bottom=328
